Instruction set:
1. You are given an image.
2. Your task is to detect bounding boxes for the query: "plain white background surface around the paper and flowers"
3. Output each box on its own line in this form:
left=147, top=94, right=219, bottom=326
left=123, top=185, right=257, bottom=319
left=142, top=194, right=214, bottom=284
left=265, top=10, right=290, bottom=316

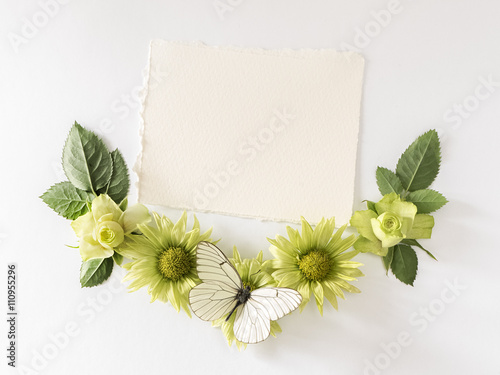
left=0, top=0, right=500, bottom=374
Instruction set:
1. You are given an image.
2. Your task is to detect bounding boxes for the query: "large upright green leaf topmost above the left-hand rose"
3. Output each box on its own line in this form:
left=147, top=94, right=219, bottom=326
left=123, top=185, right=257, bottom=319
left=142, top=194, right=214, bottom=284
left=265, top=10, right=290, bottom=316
left=62, top=122, right=113, bottom=192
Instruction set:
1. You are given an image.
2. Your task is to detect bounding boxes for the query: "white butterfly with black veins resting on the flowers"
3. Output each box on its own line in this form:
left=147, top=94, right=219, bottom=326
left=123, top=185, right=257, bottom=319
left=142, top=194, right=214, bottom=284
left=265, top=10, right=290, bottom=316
left=189, top=242, right=302, bottom=344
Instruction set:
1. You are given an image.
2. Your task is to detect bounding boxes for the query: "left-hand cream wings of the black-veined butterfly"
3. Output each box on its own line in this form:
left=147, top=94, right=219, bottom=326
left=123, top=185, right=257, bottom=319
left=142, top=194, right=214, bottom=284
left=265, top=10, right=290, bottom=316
left=189, top=242, right=243, bottom=321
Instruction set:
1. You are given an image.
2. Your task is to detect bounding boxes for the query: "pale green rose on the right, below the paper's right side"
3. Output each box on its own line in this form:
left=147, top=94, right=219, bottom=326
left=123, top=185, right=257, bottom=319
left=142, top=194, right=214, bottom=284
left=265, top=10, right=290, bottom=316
left=351, top=193, right=434, bottom=256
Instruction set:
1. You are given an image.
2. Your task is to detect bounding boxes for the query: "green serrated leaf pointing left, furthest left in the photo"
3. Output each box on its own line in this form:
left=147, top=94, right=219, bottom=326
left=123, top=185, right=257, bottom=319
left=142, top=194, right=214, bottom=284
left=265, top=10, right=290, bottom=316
left=40, top=181, right=94, bottom=220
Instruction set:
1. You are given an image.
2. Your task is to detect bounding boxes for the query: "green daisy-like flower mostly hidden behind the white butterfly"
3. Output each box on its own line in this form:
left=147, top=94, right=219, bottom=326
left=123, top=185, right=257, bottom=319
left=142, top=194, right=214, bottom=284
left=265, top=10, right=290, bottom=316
left=212, top=246, right=281, bottom=350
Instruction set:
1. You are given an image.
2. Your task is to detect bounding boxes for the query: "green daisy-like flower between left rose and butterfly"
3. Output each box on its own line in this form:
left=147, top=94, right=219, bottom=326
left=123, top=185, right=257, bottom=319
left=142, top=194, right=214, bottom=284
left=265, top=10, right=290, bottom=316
left=118, top=212, right=212, bottom=316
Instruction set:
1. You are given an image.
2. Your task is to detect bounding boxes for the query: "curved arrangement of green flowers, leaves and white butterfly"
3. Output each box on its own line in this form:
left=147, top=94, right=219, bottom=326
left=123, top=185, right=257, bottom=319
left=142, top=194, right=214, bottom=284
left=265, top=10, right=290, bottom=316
left=40, top=123, right=447, bottom=350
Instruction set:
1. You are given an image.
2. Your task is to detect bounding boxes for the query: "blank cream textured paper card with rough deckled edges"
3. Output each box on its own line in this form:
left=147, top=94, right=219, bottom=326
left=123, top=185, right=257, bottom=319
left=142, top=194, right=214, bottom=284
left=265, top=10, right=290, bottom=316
left=136, top=41, right=364, bottom=225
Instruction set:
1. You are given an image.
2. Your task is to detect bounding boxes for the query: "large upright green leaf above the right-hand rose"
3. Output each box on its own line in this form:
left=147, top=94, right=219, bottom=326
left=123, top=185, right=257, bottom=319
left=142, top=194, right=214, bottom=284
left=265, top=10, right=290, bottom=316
left=396, top=130, right=441, bottom=191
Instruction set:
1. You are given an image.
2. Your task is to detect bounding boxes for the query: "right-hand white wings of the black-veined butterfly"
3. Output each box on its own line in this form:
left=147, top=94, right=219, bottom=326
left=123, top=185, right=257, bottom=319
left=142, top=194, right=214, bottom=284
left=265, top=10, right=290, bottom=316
left=233, top=288, right=302, bottom=344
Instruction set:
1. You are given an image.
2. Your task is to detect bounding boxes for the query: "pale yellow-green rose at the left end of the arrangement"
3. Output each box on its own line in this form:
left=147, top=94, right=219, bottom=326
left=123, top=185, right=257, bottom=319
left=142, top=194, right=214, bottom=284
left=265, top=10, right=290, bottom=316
left=71, top=194, right=151, bottom=261
